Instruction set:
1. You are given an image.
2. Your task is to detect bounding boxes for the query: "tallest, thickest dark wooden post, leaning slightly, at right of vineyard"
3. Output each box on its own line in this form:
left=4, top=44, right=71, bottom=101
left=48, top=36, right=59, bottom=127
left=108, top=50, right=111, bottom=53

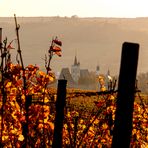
left=112, top=42, right=139, bottom=148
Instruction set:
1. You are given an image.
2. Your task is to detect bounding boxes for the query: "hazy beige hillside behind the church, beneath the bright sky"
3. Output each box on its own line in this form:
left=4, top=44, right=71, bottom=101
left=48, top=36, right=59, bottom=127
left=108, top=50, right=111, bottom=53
left=0, top=17, right=148, bottom=74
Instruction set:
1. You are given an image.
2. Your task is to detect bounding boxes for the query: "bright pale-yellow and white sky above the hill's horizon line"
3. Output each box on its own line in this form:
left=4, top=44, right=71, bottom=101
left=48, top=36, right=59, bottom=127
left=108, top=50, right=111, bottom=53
left=0, top=0, right=148, bottom=17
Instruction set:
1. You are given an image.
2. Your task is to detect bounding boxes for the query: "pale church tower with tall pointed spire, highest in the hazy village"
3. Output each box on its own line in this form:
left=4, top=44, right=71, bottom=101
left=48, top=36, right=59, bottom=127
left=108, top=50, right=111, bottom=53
left=71, top=56, right=80, bottom=84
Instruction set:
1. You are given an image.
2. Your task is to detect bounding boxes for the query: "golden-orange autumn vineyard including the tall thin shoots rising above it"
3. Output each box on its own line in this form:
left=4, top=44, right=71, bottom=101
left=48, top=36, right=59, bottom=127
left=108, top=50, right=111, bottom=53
left=0, top=14, right=148, bottom=148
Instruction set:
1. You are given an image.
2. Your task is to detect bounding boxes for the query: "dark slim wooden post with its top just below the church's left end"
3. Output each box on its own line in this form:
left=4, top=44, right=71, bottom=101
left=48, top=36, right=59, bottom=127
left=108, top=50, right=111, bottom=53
left=52, top=80, right=67, bottom=148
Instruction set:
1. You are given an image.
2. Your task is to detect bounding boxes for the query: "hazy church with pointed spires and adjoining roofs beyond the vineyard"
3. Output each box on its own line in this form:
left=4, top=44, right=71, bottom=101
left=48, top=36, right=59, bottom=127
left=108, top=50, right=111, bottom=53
left=59, top=56, right=113, bottom=91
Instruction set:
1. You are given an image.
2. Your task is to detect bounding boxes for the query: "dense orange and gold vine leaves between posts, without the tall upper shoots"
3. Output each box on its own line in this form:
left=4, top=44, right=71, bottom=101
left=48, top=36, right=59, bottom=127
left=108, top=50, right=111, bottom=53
left=0, top=65, right=148, bottom=147
